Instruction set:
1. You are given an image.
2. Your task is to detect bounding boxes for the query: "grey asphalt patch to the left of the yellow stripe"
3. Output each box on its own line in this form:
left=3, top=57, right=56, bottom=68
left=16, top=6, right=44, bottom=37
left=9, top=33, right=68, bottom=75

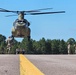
left=0, top=55, right=20, bottom=75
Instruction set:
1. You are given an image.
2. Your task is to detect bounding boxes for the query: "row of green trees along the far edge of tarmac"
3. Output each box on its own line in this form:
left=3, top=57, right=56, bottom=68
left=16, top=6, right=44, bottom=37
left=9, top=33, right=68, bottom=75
left=0, top=34, right=76, bottom=54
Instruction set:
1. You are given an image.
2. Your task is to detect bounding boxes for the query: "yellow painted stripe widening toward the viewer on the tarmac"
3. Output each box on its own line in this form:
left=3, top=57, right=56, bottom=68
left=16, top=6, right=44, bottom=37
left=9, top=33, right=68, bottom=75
left=20, top=55, right=44, bottom=75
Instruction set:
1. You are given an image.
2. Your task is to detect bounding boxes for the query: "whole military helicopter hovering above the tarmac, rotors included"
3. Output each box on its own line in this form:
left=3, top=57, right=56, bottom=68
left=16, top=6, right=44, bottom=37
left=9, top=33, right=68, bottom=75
left=0, top=8, right=65, bottom=50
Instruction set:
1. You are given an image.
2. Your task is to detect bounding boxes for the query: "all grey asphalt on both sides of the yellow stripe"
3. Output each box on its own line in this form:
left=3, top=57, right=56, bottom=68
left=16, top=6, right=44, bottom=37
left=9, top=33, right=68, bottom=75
left=0, top=55, right=76, bottom=75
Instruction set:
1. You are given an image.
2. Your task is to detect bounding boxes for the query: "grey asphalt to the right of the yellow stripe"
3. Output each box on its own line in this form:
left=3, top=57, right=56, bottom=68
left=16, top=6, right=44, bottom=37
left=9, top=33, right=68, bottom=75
left=25, top=55, right=76, bottom=75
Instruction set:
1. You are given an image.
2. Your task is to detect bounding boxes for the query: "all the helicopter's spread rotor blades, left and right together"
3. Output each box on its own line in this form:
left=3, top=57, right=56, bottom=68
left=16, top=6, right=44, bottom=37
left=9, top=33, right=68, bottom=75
left=0, top=8, right=65, bottom=17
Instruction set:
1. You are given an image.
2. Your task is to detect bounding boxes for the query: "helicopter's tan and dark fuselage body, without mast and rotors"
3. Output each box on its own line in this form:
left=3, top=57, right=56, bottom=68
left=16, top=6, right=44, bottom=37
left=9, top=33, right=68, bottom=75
left=12, top=19, right=30, bottom=37
